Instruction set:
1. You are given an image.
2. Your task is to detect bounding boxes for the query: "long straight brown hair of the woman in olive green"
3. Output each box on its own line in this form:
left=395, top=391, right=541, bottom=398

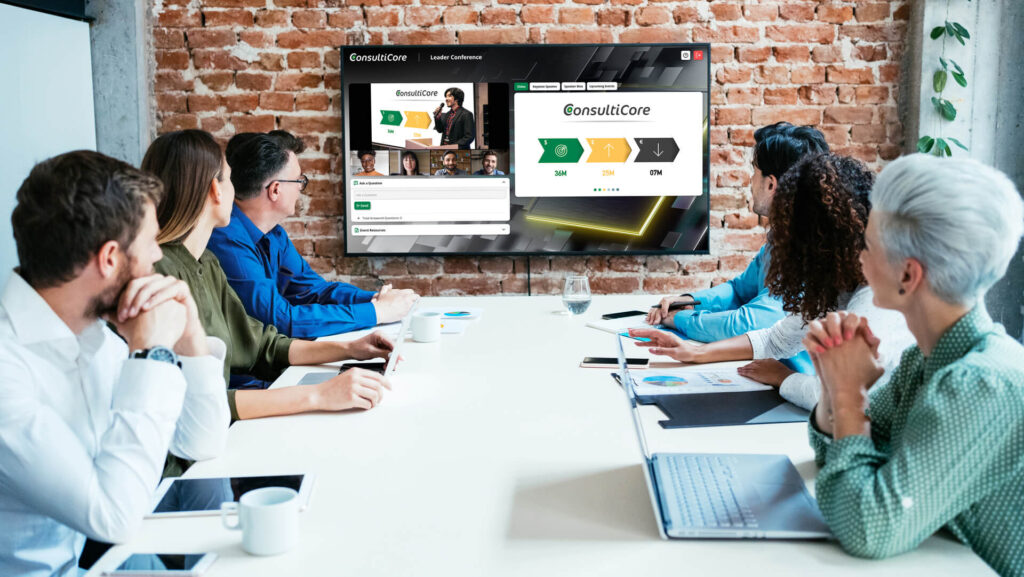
left=142, top=129, right=223, bottom=244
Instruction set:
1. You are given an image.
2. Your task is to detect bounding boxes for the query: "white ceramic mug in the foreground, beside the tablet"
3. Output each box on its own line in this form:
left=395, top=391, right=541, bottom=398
left=220, top=487, right=299, bottom=555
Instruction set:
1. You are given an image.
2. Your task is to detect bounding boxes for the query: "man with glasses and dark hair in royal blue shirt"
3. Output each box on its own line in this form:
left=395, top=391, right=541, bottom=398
left=209, top=130, right=418, bottom=338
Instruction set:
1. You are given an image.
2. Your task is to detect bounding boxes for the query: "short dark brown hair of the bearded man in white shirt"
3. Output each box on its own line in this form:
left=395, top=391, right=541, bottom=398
left=10, top=151, right=163, bottom=289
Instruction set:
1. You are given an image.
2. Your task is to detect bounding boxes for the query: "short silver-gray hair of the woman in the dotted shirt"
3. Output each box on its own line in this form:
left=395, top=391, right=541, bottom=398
left=871, top=154, right=1024, bottom=305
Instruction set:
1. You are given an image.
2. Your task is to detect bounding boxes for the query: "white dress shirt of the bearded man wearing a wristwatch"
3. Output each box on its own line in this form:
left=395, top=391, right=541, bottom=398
left=0, top=273, right=229, bottom=576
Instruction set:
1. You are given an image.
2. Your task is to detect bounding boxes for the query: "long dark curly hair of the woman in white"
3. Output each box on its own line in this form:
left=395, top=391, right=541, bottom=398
left=765, top=154, right=874, bottom=321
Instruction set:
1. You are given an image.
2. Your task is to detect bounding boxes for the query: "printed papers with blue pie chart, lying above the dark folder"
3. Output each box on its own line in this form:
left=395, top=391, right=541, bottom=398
left=630, top=367, right=771, bottom=397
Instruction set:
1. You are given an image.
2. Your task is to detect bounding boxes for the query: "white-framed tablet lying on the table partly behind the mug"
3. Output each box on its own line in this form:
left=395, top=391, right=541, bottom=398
left=146, top=472, right=316, bottom=518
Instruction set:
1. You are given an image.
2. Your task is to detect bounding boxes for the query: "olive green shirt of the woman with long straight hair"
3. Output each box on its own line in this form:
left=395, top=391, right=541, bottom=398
left=156, top=243, right=294, bottom=422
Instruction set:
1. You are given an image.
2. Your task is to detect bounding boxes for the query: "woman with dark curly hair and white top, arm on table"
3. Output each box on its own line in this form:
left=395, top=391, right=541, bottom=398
left=630, top=154, right=913, bottom=410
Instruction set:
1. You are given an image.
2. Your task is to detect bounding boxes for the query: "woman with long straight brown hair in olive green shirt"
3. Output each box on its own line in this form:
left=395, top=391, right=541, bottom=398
left=142, top=130, right=392, bottom=419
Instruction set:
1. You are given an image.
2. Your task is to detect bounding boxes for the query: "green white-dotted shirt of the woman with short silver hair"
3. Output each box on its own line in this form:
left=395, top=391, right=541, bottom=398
left=810, top=304, right=1024, bottom=576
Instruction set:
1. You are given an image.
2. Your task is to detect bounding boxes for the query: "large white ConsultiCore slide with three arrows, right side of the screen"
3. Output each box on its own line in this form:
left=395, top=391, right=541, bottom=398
left=515, top=91, right=703, bottom=197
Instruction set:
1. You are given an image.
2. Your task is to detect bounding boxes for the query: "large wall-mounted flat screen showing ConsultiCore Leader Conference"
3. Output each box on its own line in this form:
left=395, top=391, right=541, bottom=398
left=340, top=44, right=711, bottom=255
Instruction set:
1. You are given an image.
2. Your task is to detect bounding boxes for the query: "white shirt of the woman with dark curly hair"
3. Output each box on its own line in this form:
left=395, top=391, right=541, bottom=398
left=746, top=285, right=915, bottom=411
